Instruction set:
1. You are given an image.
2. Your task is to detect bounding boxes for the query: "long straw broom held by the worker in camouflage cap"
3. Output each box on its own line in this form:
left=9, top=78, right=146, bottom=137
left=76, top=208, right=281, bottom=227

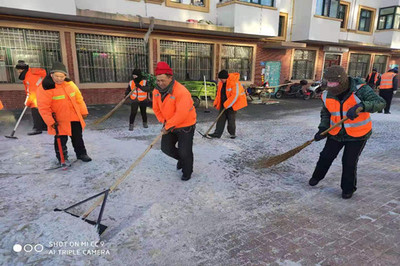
left=256, top=107, right=362, bottom=168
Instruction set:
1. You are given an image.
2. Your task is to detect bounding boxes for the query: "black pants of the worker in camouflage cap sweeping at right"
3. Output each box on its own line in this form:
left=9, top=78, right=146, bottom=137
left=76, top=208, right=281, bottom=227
left=312, top=139, right=367, bottom=193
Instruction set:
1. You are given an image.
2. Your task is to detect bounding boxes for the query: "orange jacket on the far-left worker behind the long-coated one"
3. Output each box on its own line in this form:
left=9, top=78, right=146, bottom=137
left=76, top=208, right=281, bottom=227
left=23, top=68, right=46, bottom=108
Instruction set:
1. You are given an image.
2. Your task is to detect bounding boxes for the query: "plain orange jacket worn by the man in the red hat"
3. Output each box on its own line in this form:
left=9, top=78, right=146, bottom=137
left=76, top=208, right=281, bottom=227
left=153, top=81, right=196, bottom=130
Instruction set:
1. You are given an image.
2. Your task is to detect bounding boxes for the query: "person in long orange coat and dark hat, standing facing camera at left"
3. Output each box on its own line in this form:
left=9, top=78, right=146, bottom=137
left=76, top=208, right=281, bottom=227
left=37, top=62, right=92, bottom=165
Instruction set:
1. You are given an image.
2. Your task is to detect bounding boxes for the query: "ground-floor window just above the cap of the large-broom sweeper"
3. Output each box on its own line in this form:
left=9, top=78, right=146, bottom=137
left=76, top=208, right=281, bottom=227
left=292, top=50, right=317, bottom=79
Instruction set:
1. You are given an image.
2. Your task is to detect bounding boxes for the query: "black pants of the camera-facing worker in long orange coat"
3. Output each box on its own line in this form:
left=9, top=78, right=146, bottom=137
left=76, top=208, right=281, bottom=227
left=54, top=121, right=87, bottom=161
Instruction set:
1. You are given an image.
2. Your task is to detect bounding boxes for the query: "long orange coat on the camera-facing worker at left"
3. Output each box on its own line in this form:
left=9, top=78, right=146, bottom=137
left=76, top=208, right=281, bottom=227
left=37, top=81, right=88, bottom=136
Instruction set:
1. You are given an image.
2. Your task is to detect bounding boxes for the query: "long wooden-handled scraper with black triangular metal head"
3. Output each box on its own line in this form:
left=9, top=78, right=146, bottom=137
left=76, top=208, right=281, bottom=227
left=54, top=132, right=163, bottom=235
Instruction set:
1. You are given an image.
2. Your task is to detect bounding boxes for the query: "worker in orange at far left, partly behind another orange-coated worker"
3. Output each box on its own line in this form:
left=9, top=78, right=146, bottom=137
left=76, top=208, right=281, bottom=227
left=15, top=60, right=47, bottom=135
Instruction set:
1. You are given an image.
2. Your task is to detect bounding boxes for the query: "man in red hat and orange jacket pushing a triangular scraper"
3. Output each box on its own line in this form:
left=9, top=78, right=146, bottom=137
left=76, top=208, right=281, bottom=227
left=153, top=62, right=196, bottom=181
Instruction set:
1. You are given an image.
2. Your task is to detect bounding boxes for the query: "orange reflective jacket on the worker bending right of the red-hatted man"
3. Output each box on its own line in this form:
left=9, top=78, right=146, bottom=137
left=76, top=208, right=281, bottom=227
left=214, top=73, right=247, bottom=111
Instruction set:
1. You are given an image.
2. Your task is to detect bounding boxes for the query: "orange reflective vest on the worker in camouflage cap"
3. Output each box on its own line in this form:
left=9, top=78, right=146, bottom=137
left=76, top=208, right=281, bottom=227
left=321, top=84, right=372, bottom=137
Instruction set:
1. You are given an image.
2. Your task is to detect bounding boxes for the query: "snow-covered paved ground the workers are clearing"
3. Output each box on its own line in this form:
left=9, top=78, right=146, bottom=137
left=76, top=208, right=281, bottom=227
left=0, top=99, right=400, bottom=265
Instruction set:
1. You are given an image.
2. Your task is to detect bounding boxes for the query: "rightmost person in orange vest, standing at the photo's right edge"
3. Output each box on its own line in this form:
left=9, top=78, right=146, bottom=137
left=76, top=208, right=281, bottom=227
left=379, top=67, right=399, bottom=114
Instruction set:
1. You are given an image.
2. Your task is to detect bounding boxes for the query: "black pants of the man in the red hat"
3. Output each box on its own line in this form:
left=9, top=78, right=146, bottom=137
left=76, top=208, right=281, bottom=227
left=161, top=125, right=196, bottom=177
